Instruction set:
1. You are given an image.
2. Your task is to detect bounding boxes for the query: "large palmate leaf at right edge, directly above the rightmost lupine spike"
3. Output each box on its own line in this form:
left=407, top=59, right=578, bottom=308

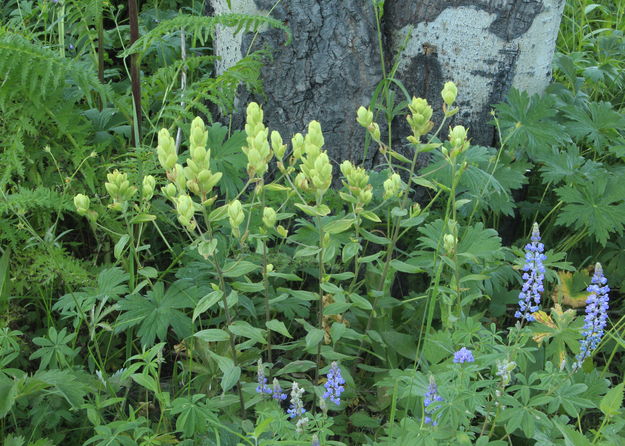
left=556, top=176, right=625, bottom=246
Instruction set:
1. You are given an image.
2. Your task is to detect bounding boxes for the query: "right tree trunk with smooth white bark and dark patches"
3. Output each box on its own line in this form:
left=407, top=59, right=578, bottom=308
left=385, top=0, right=565, bottom=145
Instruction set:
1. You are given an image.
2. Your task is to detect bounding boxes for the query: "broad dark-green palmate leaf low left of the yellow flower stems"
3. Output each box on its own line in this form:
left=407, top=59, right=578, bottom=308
left=115, top=279, right=200, bottom=347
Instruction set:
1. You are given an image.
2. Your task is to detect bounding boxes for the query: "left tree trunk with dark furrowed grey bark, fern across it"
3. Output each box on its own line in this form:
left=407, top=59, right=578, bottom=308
left=210, top=0, right=382, bottom=166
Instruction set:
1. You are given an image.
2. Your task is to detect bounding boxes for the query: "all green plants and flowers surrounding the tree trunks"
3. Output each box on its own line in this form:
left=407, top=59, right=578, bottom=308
left=0, top=0, right=625, bottom=446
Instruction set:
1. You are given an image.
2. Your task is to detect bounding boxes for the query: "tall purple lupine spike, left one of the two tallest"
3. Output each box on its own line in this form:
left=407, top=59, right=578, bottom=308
left=514, top=223, right=547, bottom=322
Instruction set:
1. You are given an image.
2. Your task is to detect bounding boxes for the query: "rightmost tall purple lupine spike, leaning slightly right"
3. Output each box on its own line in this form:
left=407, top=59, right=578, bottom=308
left=574, top=263, right=610, bottom=369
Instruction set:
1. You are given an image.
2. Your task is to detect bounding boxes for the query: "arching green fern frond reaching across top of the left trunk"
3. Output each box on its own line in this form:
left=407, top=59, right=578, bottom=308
left=122, top=14, right=291, bottom=57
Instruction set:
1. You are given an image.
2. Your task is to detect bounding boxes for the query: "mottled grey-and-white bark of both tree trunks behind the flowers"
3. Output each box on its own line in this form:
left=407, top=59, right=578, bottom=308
left=207, top=0, right=565, bottom=159
